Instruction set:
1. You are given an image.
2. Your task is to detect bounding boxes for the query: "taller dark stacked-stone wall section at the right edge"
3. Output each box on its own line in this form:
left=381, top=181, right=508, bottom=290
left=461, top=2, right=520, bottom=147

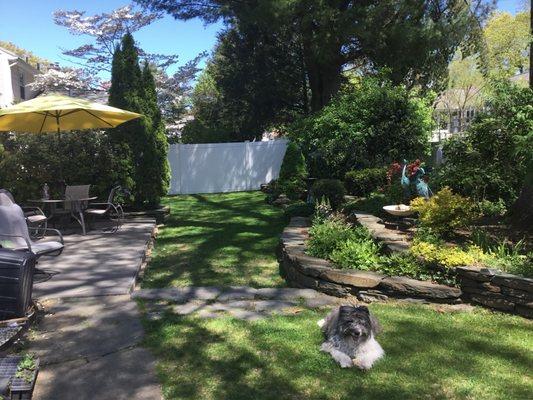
left=456, top=267, right=533, bottom=319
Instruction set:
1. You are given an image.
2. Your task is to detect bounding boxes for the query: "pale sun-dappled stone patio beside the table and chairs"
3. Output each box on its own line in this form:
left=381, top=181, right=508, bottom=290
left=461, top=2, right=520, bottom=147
left=33, top=219, right=155, bottom=300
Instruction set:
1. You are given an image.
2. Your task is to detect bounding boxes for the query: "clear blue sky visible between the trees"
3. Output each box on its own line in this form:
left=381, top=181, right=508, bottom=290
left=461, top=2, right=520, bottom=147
left=0, top=0, right=525, bottom=79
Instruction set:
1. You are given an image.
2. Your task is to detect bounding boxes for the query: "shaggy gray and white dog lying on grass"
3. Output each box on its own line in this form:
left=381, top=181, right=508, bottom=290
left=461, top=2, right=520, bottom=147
left=318, top=305, right=385, bottom=370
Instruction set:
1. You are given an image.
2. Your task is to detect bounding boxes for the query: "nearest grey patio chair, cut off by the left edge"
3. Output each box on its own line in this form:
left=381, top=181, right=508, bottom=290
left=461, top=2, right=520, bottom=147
left=0, top=193, right=64, bottom=258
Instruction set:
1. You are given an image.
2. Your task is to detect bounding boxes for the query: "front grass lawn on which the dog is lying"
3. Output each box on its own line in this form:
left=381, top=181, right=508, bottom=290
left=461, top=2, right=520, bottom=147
left=145, top=304, right=533, bottom=400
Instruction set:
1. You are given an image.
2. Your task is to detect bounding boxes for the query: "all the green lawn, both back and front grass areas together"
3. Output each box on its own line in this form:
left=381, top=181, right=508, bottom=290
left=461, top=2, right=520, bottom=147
left=143, top=193, right=533, bottom=400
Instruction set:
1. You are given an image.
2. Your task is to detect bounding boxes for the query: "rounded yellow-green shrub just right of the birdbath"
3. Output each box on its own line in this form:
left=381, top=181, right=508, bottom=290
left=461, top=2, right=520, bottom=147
left=411, top=187, right=476, bottom=235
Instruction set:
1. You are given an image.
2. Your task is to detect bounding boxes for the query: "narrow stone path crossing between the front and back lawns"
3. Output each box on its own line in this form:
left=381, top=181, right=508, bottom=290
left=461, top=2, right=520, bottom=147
left=132, top=286, right=340, bottom=321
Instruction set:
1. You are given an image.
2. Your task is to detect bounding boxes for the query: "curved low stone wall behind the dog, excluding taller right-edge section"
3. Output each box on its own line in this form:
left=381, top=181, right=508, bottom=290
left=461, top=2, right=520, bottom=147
left=278, top=217, right=462, bottom=303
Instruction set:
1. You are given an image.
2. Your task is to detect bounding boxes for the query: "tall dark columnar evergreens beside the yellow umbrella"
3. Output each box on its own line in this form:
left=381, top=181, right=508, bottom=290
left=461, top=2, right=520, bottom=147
left=109, top=33, right=169, bottom=207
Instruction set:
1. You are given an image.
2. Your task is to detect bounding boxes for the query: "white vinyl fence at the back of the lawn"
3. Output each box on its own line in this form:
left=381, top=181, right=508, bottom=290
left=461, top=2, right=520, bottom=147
left=168, top=139, right=287, bottom=194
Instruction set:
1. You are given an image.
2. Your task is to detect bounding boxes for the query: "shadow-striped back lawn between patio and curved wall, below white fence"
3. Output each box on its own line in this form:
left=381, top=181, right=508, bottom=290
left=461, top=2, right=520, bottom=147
left=143, top=192, right=286, bottom=288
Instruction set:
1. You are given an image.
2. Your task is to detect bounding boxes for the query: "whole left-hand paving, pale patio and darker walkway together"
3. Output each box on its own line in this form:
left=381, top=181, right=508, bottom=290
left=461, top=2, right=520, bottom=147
left=28, top=220, right=162, bottom=400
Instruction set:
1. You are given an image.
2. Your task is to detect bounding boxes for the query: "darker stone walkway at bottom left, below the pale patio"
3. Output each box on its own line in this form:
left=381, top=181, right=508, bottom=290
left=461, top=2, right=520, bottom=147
left=29, top=295, right=161, bottom=400
